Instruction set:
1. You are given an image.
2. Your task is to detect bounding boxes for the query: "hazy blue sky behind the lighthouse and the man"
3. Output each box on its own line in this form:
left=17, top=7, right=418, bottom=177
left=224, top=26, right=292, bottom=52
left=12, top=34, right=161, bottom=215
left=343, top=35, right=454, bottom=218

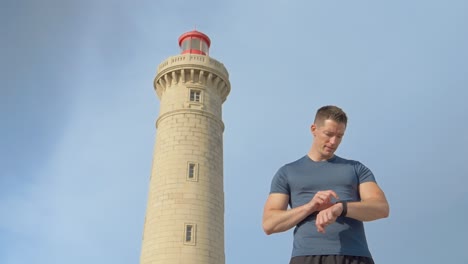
left=0, top=0, right=468, bottom=264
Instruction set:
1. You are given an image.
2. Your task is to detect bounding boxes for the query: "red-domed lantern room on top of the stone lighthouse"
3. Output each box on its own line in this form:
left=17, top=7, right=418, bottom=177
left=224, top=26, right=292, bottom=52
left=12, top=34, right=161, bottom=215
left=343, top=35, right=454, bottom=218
left=179, top=30, right=211, bottom=55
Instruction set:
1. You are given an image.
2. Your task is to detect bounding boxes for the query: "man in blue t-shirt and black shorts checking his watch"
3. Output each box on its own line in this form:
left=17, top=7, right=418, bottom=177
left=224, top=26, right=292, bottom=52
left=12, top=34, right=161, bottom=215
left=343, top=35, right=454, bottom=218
left=263, top=106, right=389, bottom=264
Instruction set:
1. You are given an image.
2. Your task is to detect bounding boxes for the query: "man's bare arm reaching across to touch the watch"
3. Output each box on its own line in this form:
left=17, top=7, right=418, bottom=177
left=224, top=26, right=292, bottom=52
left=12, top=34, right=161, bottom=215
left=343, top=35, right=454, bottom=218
left=263, top=190, right=338, bottom=235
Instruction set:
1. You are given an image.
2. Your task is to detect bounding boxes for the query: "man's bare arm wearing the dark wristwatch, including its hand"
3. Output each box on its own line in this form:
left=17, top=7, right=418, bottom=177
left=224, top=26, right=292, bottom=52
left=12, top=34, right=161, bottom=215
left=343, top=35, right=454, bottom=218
left=315, top=182, right=390, bottom=233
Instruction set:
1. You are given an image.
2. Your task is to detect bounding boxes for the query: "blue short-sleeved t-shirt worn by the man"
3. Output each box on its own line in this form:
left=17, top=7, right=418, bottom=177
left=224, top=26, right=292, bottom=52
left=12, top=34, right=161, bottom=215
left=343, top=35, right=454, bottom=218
left=270, top=155, right=375, bottom=257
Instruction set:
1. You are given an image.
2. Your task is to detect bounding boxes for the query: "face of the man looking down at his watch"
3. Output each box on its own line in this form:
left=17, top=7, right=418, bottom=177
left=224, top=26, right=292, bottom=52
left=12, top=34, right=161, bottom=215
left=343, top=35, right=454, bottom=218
left=311, top=119, right=346, bottom=159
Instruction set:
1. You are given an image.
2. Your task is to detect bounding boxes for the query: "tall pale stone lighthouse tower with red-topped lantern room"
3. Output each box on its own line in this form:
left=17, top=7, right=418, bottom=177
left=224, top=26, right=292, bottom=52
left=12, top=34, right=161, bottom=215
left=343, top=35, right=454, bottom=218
left=140, top=31, right=231, bottom=264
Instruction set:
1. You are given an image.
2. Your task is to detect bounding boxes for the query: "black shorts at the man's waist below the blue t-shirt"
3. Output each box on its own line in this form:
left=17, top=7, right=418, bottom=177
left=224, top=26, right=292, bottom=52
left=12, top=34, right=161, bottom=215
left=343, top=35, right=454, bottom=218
left=289, top=255, right=375, bottom=264
